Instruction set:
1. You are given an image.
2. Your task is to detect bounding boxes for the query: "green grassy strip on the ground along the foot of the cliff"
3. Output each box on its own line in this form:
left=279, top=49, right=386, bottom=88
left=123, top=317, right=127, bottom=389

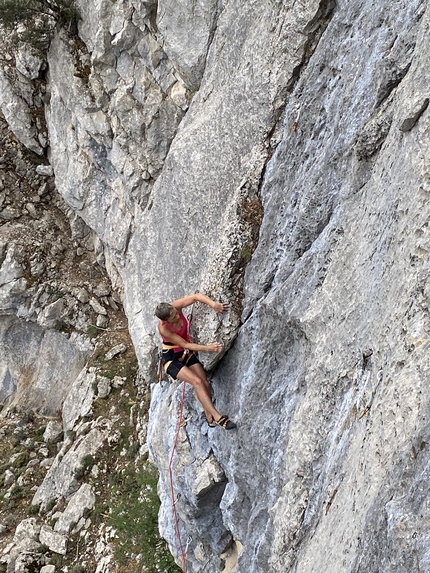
left=88, top=358, right=180, bottom=573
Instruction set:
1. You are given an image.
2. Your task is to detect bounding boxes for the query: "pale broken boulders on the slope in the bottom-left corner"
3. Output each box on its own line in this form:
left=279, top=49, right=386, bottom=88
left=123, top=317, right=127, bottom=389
left=0, top=377, right=146, bottom=573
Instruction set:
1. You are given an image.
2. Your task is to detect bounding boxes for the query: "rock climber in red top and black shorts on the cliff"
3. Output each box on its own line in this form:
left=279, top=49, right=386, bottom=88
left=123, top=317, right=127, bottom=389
left=155, top=293, right=236, bottom=430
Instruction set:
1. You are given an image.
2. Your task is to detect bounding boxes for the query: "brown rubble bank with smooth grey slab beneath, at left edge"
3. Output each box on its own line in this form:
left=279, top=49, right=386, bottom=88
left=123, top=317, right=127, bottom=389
left=0, top=108, right=129, bottom=416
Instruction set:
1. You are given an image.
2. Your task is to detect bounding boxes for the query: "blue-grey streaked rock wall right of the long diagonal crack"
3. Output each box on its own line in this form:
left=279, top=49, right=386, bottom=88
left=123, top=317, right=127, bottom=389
left=147, top=2, right=429, bottom=573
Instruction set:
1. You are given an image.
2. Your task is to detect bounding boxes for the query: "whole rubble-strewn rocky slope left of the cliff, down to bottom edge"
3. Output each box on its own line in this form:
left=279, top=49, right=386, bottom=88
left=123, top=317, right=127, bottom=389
left=0, top=97, right=149, bottom=573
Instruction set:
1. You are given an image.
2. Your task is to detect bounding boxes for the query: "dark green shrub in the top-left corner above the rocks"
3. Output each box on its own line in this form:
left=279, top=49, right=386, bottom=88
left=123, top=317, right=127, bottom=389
left=0, top=0, right=80, bottom=54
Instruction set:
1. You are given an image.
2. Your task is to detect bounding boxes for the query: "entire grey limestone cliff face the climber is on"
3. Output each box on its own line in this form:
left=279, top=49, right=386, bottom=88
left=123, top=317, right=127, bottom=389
left=0, top=0, right=430, bottom=573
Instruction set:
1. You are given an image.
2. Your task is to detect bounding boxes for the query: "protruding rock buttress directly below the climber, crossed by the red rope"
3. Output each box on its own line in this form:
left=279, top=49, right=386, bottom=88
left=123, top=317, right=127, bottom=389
left=148, top=384, right=231, bottom=571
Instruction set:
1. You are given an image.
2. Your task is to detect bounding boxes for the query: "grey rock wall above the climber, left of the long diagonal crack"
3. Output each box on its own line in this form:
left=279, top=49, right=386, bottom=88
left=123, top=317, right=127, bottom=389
left=42, top=2, right=333, bottom=366
